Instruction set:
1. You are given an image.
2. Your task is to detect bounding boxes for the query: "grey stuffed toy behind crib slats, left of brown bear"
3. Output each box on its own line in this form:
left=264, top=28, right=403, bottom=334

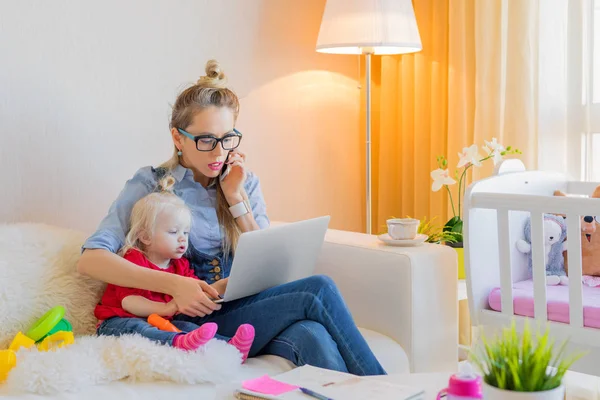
left=516, top=214, right=569, bottom=285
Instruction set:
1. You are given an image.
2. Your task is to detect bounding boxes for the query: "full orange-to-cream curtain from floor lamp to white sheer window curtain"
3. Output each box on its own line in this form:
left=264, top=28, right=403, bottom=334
left=361, top=0, right=540, bottom=233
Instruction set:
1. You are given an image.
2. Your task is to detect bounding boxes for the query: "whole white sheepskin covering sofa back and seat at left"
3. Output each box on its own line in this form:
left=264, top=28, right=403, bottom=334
left=0, top=224, right=241, bottom=394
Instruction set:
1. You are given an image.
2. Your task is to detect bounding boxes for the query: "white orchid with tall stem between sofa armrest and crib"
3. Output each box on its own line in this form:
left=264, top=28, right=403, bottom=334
left=431, top=138, right=521, bottom=279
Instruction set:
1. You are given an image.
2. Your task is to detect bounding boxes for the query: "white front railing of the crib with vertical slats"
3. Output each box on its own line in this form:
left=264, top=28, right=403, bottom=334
left=470, top=193, right=599, bottom=328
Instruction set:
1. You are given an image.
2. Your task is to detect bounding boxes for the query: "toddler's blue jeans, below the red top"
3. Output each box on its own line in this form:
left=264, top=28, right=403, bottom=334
left=97, top=317, right=229, bottom=346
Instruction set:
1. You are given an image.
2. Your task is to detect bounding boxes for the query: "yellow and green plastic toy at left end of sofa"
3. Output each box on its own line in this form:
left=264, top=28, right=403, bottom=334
left=0, top=306, right=75, bottom=382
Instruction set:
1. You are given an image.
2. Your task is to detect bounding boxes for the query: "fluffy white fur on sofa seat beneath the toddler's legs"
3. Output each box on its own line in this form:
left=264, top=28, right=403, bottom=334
left=5, top=335, right=241, bottom=394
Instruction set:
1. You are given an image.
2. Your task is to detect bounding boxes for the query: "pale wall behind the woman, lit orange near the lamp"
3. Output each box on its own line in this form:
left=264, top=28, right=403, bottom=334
left=0, top=0, right=364, bottom=231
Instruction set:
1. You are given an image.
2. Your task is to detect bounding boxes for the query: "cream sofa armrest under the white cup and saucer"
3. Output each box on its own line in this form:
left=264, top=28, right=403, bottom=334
left=316, top=230, right=458, bottom=373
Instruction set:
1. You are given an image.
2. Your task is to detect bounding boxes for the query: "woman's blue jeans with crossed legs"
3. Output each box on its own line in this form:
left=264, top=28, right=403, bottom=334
left=174, top=275, right=385, bottom=375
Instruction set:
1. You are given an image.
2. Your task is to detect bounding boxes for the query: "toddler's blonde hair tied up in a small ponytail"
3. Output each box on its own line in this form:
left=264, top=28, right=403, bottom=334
left=119, top=175, right=191, bottom=256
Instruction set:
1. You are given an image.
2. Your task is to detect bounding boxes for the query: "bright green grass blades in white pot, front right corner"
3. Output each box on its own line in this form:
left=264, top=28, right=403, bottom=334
left=471, top=321, right=583, bottom=392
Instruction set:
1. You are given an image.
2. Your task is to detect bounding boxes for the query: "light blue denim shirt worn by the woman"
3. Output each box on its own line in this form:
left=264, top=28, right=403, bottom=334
left=83, top=165, right=269, bottom=283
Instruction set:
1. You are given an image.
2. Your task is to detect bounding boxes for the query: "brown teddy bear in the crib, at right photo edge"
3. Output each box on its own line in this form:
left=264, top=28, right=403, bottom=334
left=554, top=186, right=600, bottom=287
